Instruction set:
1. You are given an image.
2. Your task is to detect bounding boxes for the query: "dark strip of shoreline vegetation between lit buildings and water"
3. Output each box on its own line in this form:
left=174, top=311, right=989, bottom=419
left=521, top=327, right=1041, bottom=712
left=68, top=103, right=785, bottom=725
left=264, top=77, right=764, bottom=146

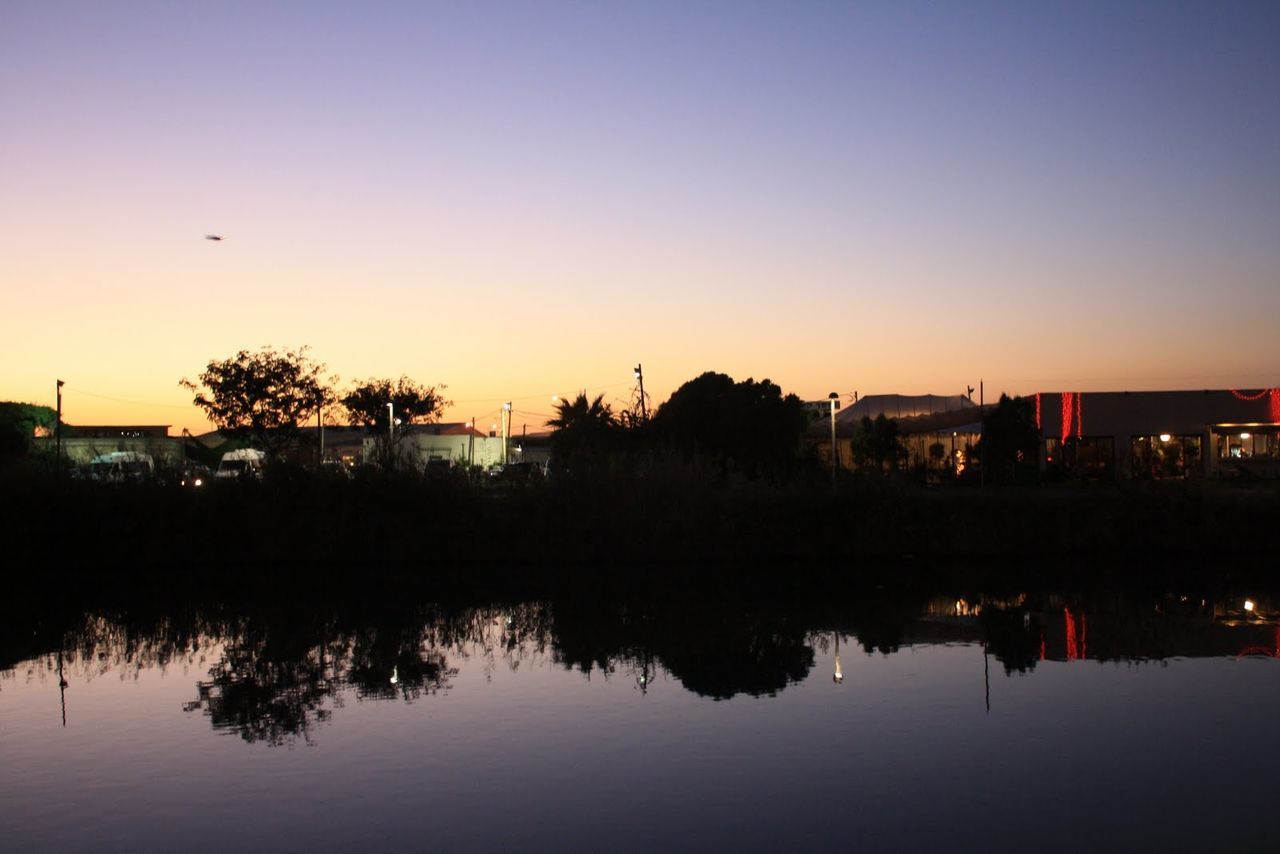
left=0, top=463, right=1280, bottom=595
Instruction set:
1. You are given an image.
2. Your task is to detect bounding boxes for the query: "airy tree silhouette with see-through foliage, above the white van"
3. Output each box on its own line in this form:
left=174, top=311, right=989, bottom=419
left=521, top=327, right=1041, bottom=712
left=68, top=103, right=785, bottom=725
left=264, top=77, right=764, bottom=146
left=178, top=347, right=335, bottom=457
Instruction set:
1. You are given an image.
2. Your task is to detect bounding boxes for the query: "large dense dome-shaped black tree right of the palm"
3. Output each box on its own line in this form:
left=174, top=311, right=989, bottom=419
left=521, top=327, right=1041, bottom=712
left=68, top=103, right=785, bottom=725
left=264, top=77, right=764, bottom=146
left=653, top=371, right=809, bottom=475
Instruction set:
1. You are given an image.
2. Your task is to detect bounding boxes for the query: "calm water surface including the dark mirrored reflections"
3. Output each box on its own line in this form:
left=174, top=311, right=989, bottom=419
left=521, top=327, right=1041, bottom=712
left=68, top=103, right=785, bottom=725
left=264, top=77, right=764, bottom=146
left=0, top=594, right=1280, bottom=851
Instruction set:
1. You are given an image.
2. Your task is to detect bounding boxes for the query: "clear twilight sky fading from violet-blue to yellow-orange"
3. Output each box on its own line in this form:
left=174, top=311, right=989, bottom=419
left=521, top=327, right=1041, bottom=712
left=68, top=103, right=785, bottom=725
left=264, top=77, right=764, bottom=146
left=0, top=0, right=1280, bottom=433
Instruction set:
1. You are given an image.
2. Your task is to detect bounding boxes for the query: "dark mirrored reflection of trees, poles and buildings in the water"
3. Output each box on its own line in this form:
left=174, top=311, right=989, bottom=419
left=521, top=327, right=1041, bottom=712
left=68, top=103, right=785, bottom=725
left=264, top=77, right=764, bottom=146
left=0, top=593, right=1280, bottom=745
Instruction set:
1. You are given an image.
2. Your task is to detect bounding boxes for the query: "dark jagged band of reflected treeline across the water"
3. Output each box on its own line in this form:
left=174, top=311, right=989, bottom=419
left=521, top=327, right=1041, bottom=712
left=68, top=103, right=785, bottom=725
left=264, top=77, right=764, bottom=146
left=0, top=575, right=1276, bottom=727
